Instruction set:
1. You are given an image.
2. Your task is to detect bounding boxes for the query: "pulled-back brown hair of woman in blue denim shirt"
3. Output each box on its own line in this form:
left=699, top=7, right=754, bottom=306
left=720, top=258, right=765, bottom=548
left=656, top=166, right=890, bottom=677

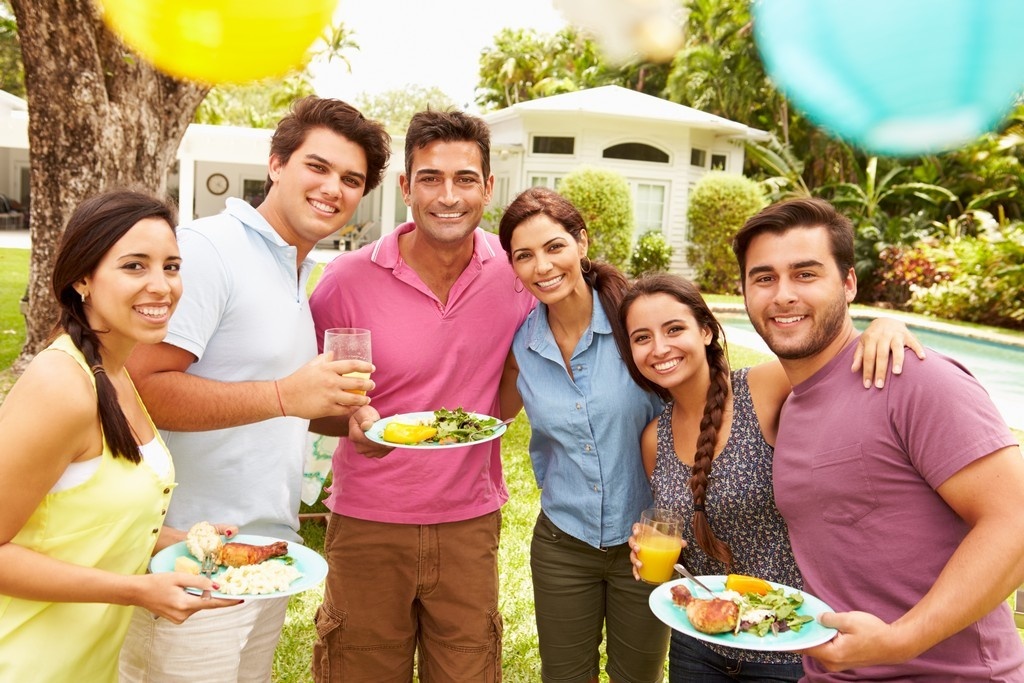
left=498, top=187, right=629, bottom=327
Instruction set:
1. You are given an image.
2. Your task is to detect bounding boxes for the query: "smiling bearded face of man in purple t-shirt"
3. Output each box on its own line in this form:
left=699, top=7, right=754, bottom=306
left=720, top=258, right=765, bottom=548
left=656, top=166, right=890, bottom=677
left=743, top=227, right=857, bottom=366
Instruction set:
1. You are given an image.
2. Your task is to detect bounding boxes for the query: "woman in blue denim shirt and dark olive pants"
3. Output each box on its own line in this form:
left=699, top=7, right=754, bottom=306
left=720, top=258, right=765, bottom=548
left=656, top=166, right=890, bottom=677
left=499, top=187, right=669, bottom=683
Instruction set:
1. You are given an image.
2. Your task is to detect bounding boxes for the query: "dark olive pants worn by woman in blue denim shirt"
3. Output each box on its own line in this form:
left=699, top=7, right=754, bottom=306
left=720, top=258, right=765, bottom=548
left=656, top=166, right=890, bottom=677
left=529, top=511, right=669, bottom=683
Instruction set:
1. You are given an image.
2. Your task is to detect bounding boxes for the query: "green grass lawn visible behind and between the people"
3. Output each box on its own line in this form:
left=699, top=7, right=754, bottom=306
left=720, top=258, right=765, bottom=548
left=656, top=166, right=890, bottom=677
left=0, top=249, right=1024, bottom=683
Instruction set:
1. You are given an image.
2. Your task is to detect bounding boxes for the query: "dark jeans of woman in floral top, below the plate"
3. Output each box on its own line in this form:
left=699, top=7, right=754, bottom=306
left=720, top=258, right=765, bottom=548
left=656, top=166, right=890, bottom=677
left=669, top=631, right=804, bottom=683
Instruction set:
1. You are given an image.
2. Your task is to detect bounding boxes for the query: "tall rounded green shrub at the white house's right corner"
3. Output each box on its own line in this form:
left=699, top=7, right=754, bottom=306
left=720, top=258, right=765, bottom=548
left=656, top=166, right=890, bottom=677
left=686, top=171, right=768, bottom=294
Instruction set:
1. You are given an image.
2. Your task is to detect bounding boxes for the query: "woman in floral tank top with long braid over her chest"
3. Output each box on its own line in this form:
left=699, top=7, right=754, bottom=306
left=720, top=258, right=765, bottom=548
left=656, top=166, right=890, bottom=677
left=618, top=274, right=917, bottom=683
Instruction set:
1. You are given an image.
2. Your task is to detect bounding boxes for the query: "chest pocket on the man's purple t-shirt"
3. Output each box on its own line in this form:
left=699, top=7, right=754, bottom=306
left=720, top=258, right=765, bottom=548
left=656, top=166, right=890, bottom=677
left=811, top=443, right=879, bottom=524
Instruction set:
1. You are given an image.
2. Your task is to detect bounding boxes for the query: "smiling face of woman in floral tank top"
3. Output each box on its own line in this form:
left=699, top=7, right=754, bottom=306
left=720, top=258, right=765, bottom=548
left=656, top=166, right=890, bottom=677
left=626, top=292, right=712, bottom=389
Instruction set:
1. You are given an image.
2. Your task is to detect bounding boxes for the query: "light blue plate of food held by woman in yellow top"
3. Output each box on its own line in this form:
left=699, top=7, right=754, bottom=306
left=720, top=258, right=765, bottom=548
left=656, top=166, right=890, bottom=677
left=150, top=522, right=327, bottom=600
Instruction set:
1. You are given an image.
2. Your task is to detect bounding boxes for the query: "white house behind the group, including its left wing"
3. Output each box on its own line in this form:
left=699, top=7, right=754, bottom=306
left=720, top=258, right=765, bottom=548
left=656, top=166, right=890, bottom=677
left=0, top=86, right=767, bottom=270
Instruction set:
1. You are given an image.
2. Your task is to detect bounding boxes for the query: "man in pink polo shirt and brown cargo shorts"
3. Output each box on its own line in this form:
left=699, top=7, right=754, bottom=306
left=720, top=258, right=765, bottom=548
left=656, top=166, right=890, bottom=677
left=310, top=112, right=534, bottom=683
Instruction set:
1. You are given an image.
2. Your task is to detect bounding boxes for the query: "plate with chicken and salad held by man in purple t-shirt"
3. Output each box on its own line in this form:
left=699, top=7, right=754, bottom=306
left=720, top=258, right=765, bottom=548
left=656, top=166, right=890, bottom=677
left=648, top=574, right=838, bottom=651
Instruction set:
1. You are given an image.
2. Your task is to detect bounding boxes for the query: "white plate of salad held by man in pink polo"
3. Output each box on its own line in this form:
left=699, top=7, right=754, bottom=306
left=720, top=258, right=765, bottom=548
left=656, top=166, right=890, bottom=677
left=367, top=408, right=508, bottom=451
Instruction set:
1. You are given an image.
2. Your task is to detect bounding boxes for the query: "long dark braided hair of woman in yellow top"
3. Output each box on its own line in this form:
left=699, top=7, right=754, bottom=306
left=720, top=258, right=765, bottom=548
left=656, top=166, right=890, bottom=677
left=51, top=189, right=177, bottom=464
